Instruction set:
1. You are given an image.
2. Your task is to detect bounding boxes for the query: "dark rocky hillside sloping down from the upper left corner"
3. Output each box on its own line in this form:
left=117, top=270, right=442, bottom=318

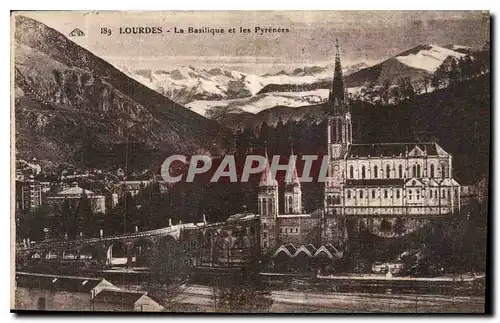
left=13, top=16, right=230, bottom=172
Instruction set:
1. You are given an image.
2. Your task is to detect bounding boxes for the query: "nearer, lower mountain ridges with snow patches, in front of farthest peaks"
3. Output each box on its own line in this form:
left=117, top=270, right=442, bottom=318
left=185, top=44, right=474, bottom=127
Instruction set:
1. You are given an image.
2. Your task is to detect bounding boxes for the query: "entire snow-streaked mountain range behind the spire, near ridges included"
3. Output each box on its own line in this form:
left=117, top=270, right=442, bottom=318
left=120, top=44, right=474, bottom=128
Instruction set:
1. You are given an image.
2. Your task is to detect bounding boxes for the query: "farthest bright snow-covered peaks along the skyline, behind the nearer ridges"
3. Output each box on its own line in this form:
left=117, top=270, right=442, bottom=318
left=119, top=63, right=367, bottom=104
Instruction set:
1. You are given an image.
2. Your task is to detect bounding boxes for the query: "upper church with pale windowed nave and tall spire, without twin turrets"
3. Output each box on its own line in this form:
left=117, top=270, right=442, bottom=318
left=324, top=44, right=461, bottom=234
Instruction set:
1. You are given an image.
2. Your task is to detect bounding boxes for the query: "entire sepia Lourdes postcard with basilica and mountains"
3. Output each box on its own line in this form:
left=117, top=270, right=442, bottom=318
left=10, top=11, right=493, bottom=315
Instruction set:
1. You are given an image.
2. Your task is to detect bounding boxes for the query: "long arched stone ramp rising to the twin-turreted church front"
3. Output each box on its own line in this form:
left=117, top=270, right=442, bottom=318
left=16, top=214, right=260, bottom=267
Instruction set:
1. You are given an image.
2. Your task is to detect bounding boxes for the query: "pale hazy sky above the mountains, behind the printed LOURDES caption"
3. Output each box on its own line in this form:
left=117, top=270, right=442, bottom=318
left=18, top=11, right=490, bottom=74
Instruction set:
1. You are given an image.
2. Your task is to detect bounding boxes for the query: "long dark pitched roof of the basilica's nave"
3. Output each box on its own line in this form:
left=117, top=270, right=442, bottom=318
left=347, top=142, right=449, bottom=158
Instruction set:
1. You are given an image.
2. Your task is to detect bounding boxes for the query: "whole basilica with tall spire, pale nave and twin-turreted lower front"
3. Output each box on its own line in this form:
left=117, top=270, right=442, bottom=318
left=258, top=43, right=460, bottom=250
